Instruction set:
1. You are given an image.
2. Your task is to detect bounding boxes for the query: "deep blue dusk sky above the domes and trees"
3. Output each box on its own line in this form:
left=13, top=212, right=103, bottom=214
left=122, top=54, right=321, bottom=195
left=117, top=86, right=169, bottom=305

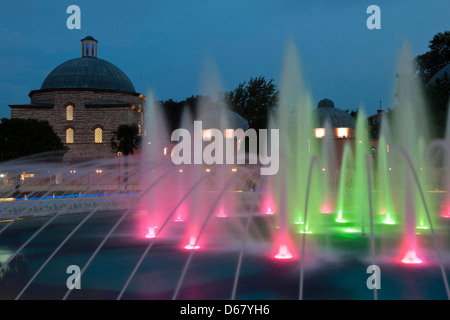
left=0, top=0, right=450, bottom=118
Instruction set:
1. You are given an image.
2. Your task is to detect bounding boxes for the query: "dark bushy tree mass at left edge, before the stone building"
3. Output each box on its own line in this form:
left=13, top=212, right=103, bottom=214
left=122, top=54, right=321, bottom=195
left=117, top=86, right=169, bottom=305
left=0, top=118, right=68, bottom=161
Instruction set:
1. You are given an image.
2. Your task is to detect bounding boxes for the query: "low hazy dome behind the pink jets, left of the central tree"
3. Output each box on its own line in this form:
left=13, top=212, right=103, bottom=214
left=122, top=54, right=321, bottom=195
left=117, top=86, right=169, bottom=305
left=197, top=109, right=249, bottom=131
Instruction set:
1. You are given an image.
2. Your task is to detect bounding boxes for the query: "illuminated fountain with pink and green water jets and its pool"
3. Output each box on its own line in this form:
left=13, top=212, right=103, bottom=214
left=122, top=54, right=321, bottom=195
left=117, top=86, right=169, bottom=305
left=0, top=40, right=450, bottom=299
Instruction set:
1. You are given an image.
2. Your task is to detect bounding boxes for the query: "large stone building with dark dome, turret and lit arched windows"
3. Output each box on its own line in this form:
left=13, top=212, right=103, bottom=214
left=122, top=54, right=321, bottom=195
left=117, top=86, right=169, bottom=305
left=10, top=36, right=145, bottom=161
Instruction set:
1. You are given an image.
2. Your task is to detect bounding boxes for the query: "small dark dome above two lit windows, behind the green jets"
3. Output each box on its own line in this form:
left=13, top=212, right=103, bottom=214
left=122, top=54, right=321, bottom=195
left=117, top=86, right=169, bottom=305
left=316, top=99, right=355, bottom=128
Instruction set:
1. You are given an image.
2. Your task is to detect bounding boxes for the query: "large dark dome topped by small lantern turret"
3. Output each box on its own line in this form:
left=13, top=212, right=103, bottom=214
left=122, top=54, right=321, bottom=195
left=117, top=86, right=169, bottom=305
left=41, top=36, right=136, bottom=93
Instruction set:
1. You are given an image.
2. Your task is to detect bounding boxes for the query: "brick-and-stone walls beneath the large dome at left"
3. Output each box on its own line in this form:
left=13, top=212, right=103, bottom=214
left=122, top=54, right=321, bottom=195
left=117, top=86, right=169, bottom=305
left=11, top=89, right=145, bottom=161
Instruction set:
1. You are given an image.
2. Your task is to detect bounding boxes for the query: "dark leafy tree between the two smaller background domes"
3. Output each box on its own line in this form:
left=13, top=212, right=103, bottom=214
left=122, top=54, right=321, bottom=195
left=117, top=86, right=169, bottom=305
left=224, top=76, right=279, bottom=129
